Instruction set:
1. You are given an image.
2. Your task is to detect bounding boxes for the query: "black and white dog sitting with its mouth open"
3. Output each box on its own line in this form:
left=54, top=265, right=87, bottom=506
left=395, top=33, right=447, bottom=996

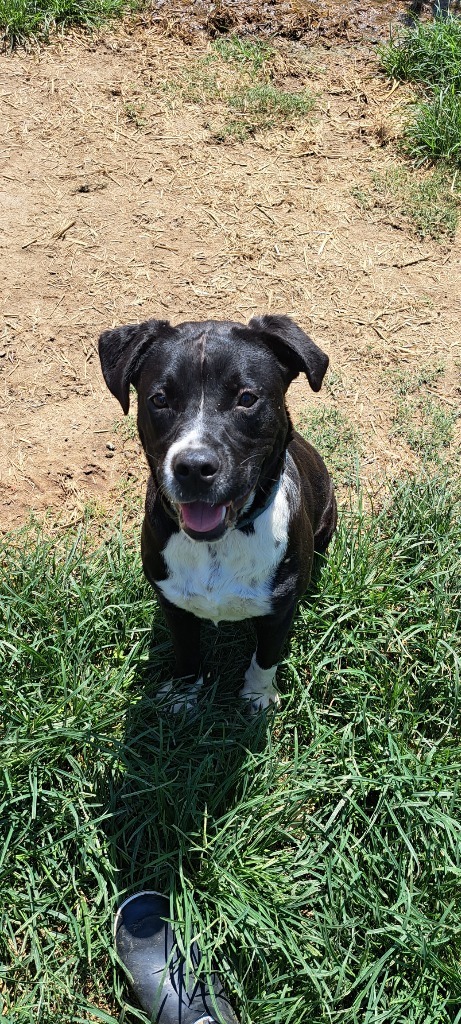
left=99, top=315, right=336, bottom=710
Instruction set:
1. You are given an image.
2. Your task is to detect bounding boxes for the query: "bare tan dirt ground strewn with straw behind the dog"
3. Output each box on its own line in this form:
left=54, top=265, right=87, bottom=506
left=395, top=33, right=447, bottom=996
left=0, top=22, right=461, bottom=528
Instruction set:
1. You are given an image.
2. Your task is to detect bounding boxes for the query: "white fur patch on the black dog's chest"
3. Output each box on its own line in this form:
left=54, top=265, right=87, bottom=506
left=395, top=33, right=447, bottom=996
left=157, top=480, right=290, bottom=623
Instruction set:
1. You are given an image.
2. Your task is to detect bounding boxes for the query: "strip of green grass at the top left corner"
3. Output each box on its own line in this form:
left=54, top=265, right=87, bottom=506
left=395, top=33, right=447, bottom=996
left=0, top=0, right=137, bottom=47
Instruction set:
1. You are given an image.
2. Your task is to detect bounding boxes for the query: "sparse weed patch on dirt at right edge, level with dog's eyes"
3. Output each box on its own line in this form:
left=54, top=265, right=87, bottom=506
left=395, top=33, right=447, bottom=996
left=393, top=396, right=459, bottom=465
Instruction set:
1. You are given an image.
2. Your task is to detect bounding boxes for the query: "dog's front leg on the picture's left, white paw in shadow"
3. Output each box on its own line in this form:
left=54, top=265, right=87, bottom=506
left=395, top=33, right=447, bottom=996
left=159, top=596, right=203, bottom=711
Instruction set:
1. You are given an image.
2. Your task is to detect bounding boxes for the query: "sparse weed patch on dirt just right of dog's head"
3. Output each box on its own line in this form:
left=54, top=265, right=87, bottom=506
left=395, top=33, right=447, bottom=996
left=296, top=406, right=362, bottom=485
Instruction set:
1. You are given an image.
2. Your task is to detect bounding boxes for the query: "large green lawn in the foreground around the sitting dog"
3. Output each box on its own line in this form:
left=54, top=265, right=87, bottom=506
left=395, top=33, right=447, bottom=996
left=0, top=477, right=461, bottom=1024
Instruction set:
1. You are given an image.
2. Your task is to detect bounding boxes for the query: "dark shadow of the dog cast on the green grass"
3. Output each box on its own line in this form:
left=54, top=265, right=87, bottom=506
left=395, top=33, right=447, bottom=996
left=101, top=608, right=271, bottom=896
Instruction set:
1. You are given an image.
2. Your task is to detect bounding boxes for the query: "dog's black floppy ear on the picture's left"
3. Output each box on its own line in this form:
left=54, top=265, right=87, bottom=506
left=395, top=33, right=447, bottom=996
left=99, top=319, right=172, bottom=416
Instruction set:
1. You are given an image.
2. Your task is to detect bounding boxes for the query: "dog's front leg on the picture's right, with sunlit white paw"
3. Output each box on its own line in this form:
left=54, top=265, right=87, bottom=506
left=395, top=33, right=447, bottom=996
left=240, top=602, right=296, bottom=712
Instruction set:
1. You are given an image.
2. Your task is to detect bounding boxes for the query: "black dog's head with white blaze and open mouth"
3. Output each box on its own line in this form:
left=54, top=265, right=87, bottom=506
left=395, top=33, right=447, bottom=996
left=99, top=315, right=328, bottom=541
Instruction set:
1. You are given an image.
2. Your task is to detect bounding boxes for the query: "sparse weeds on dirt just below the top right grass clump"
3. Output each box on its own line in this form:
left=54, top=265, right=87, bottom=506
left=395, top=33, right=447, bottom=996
left=351, top=167, right=461, bottom=241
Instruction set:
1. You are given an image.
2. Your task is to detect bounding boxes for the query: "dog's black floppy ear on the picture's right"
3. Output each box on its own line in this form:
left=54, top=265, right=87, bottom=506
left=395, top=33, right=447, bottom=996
left=248, top=314, right=329, bottom=391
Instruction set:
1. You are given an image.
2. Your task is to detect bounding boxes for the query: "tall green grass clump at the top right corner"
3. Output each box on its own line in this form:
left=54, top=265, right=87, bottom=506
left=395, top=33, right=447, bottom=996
left=380, top=17, right=461, bottom=166
